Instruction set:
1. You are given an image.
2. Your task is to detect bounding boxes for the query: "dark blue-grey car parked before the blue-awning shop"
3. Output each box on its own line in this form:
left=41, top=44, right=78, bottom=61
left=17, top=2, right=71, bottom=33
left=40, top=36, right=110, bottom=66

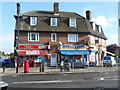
left=68, top=59, right=88, bottom=68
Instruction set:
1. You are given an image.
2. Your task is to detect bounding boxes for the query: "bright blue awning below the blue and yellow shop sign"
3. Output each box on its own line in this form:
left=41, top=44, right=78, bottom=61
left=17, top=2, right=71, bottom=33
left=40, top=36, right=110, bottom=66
left=60, top=50, right=89, bottom=55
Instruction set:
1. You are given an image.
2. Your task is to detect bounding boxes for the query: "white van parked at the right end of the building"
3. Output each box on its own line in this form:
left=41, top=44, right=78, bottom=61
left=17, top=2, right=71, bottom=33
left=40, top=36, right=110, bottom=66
left=103, top=56, right=116, bottom=67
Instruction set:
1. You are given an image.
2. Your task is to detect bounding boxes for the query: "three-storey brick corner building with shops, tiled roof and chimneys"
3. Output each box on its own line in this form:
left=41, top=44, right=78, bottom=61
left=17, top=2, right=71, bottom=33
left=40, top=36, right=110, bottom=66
left=14, top=3, right=107, bottom=66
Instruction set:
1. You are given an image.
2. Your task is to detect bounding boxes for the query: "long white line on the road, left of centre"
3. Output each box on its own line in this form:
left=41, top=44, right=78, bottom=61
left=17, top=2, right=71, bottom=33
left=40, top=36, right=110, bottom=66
left=13, top=80, right=71, bottom=84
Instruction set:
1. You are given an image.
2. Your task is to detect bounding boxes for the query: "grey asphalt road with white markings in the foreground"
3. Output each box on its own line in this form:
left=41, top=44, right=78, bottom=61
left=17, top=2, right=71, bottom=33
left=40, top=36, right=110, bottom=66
left=3, top=72, right=120, bottom=90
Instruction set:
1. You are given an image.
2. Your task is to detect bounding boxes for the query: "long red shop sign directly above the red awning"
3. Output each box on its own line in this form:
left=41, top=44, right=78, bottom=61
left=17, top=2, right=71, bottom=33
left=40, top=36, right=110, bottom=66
left=18, top=45, right=48, bottom=49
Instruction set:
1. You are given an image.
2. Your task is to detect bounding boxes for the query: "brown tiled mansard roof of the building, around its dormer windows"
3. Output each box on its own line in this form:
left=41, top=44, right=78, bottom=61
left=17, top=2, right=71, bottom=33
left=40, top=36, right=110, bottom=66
left=16, top=10, right=107, bottom=39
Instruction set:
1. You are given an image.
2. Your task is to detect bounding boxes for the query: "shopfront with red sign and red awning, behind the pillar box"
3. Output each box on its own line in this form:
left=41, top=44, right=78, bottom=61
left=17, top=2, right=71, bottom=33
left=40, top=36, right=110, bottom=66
left=18, top=44, right=48, bottom=67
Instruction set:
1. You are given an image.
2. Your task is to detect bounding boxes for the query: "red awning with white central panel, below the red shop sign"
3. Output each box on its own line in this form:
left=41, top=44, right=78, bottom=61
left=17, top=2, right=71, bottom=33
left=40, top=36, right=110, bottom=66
left=18, top=50, right=48, bottom=56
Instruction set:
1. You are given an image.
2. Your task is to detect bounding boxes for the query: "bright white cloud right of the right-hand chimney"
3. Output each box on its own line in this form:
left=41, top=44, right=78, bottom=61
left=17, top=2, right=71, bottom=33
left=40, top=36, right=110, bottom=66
left=92, top=15, right=111, bottom=27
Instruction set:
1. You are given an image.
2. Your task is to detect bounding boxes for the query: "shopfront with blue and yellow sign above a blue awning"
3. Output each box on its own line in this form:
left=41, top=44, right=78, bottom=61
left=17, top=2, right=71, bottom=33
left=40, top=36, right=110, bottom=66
left=60, top=45, right=89, bottom=61
